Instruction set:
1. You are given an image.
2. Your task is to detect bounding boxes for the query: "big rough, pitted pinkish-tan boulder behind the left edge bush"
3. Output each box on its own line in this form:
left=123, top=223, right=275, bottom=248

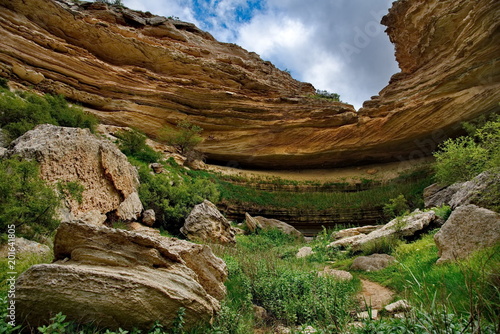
left=7, top=124, right=142, bottom=221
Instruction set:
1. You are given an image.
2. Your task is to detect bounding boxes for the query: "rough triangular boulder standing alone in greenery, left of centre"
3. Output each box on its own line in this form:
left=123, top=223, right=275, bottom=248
left=181, top=200, right=236, bottom=244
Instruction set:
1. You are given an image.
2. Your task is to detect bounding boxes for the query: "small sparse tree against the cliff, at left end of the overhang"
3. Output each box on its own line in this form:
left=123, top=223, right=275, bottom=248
left=160, top=121, right=203, bottom=156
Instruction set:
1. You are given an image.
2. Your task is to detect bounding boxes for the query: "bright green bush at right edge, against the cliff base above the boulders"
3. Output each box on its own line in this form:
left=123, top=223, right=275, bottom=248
left=434, top=115, right=500, bottom=185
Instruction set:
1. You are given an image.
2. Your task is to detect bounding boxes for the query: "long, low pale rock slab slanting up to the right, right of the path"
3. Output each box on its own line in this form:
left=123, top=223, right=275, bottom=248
left=328, top=209, right=436, bottom=251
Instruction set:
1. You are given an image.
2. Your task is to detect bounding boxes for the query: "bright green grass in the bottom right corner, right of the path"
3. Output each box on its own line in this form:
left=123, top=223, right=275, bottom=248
left=362, top=232, right=500, bottom=333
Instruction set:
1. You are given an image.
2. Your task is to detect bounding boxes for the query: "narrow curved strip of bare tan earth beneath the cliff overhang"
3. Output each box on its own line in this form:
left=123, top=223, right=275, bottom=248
left=207, top=157, right=434, bottom=183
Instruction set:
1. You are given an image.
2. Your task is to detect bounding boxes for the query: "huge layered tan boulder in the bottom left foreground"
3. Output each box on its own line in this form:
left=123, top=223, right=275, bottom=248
left=16, top=222, right=227, bottom=330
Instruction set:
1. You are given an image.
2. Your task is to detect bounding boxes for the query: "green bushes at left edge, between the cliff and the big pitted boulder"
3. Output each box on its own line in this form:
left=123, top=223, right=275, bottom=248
left=0, top=88, right=97, bottom=140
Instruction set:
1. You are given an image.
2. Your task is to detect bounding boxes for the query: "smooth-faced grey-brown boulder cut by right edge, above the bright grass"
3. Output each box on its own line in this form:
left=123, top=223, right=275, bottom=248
left=434, top=204, right=500, bottom=263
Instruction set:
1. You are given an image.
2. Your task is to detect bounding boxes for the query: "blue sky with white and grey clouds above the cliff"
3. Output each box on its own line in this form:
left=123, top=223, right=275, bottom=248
left=123, top=0, right=399, bottom=109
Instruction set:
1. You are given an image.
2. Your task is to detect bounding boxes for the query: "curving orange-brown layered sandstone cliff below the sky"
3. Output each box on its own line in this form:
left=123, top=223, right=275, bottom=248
left=0, top=0, right=500, bottom=168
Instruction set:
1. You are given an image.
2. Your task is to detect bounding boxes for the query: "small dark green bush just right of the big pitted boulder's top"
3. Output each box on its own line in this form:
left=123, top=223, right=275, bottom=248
left=115, top=130, right=161, bottom=163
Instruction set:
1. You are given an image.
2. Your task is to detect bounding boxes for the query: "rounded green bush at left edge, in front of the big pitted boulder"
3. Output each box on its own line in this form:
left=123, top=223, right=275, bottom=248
left=0, top=158, right=60, bottom=239
